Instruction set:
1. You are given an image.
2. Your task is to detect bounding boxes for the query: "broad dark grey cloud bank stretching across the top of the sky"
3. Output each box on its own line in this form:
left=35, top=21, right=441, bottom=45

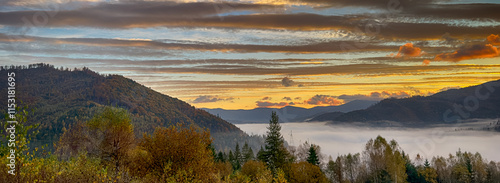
left=0, top=0, right=500, bottom=40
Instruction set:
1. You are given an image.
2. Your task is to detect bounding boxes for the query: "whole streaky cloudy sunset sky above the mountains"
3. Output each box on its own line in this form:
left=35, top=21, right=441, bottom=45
left=0, top=0, right=500, bottom=109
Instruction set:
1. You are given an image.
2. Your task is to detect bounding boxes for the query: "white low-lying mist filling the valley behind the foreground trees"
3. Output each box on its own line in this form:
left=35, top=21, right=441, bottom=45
left=236, top=120, right=500, bottom=161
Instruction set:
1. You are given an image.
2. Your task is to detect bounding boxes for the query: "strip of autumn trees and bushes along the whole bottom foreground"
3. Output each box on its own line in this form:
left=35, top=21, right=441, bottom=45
left=0, top=107, right=500, bottom=183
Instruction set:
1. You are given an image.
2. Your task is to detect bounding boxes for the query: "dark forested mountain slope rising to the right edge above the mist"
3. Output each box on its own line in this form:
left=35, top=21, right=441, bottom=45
left=311, top=80, right=500, bottom=125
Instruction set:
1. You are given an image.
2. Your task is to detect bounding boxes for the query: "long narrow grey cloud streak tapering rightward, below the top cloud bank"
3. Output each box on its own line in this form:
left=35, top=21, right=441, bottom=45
left=0, top=34, right=397, bottom=53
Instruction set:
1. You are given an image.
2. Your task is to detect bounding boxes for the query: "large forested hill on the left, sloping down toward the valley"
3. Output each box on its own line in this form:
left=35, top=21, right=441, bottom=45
left=0, top=64, right=245, bottom=150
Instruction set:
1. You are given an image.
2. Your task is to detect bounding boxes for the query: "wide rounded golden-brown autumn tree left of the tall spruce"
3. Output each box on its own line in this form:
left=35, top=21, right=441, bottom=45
left=139, top=125, right=217, bottom=182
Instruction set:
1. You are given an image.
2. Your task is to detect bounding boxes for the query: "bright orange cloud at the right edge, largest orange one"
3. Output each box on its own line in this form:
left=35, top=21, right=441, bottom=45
left=434, top=44, right=499, bottom=62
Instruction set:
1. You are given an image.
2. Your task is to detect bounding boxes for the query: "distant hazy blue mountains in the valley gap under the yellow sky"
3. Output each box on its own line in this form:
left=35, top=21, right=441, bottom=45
left=203, top=100, right=377, bottom=124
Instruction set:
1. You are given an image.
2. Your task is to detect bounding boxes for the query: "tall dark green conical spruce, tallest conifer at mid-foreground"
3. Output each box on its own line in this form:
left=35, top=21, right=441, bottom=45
left=264, top=111, right=291, bottom=173
